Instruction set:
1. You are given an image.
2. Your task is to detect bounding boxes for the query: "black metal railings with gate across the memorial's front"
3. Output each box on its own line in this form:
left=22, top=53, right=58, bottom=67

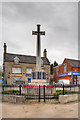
left=0, top=84, right=80, bottom=102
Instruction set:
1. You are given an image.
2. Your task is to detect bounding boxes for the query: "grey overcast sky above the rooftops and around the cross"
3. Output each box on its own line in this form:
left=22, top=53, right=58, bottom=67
left=0, top=2, right=78, bottom=64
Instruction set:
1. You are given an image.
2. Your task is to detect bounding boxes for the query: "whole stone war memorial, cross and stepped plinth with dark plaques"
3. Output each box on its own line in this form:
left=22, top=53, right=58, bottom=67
left=29, top=24, right=49, bottom=85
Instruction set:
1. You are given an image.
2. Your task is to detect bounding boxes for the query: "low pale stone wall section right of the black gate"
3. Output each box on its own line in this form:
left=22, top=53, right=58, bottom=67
left=59, top=94, right=78, bottom=104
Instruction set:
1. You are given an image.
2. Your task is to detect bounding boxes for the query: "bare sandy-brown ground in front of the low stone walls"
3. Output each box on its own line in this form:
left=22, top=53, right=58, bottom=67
left=0, top=102, right=78, bottom=118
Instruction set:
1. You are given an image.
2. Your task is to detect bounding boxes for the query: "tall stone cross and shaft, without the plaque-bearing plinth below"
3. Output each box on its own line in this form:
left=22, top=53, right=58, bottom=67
left=32, top=24, right=45, bottom=71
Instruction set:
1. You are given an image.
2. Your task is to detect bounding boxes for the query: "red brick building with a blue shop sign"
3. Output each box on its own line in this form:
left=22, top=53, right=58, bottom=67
left=53, top=58, right=80, bottom=84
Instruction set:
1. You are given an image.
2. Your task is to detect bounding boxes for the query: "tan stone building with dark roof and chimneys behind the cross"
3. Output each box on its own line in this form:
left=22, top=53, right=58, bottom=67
left=3, top=43, right=50, bottom=84
